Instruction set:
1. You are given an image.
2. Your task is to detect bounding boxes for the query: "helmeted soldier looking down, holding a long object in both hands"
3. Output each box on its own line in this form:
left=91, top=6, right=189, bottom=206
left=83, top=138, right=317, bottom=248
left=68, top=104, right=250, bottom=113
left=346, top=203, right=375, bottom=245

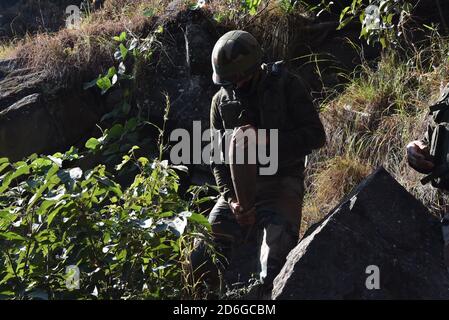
left=191, top=30, right=326, bottom=293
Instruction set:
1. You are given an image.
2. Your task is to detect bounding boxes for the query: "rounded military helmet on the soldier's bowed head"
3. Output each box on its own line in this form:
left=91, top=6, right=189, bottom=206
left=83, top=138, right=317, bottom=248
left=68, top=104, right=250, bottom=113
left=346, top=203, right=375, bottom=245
left=212, top=30, right=262, bottom=85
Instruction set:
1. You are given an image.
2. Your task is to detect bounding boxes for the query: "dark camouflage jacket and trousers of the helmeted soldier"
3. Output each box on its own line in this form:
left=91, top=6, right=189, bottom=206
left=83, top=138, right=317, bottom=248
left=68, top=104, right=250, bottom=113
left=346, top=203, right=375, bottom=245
left=192, top=63, right=325, bottom=287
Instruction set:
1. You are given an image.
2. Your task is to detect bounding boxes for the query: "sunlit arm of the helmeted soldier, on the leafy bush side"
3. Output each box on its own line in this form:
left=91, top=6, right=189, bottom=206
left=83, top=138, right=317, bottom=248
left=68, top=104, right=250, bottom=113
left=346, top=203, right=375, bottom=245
left=210, top=95, right=235, bottom=203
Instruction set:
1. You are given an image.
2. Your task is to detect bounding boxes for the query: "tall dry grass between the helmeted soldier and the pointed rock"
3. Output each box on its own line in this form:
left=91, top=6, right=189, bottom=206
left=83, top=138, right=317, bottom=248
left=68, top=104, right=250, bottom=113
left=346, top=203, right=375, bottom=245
left=303, top=36, right=449, bottom=232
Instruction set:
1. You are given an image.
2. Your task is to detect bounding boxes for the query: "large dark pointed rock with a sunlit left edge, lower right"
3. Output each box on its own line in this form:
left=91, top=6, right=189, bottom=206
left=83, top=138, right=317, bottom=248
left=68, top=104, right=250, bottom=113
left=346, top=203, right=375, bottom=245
left=272, top=168, right=449, bottom=299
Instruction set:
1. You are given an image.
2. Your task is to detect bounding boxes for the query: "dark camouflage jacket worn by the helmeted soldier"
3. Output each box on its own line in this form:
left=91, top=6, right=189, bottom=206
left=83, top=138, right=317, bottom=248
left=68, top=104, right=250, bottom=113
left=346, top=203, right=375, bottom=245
left=210, top=63, right=326, bottom=201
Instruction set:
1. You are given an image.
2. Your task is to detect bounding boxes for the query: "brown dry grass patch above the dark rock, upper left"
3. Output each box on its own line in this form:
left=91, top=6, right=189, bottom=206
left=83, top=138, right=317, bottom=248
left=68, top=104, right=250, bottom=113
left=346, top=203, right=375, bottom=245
left=17, top=0, right=167, bottom=84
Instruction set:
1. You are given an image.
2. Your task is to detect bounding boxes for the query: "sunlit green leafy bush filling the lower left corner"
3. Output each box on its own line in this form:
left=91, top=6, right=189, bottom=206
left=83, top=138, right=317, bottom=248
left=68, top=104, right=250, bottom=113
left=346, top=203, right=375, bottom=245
left=0, top=130, right=215, bottom=299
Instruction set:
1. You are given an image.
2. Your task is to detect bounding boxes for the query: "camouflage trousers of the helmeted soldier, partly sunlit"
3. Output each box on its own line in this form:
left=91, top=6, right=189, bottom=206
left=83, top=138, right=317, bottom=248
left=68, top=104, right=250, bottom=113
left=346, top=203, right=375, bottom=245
left=191, top=176, right=304, bottom=290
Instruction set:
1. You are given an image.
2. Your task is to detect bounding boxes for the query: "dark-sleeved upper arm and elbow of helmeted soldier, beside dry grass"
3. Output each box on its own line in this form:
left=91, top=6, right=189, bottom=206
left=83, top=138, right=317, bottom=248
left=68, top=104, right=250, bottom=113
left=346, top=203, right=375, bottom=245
left=279, top=75, right=326, bottom=157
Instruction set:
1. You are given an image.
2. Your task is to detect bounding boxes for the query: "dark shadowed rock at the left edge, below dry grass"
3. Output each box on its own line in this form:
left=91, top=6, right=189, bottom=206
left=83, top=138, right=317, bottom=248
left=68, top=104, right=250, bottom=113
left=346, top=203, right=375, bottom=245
left=0, top=61, right=106, bottom=161
